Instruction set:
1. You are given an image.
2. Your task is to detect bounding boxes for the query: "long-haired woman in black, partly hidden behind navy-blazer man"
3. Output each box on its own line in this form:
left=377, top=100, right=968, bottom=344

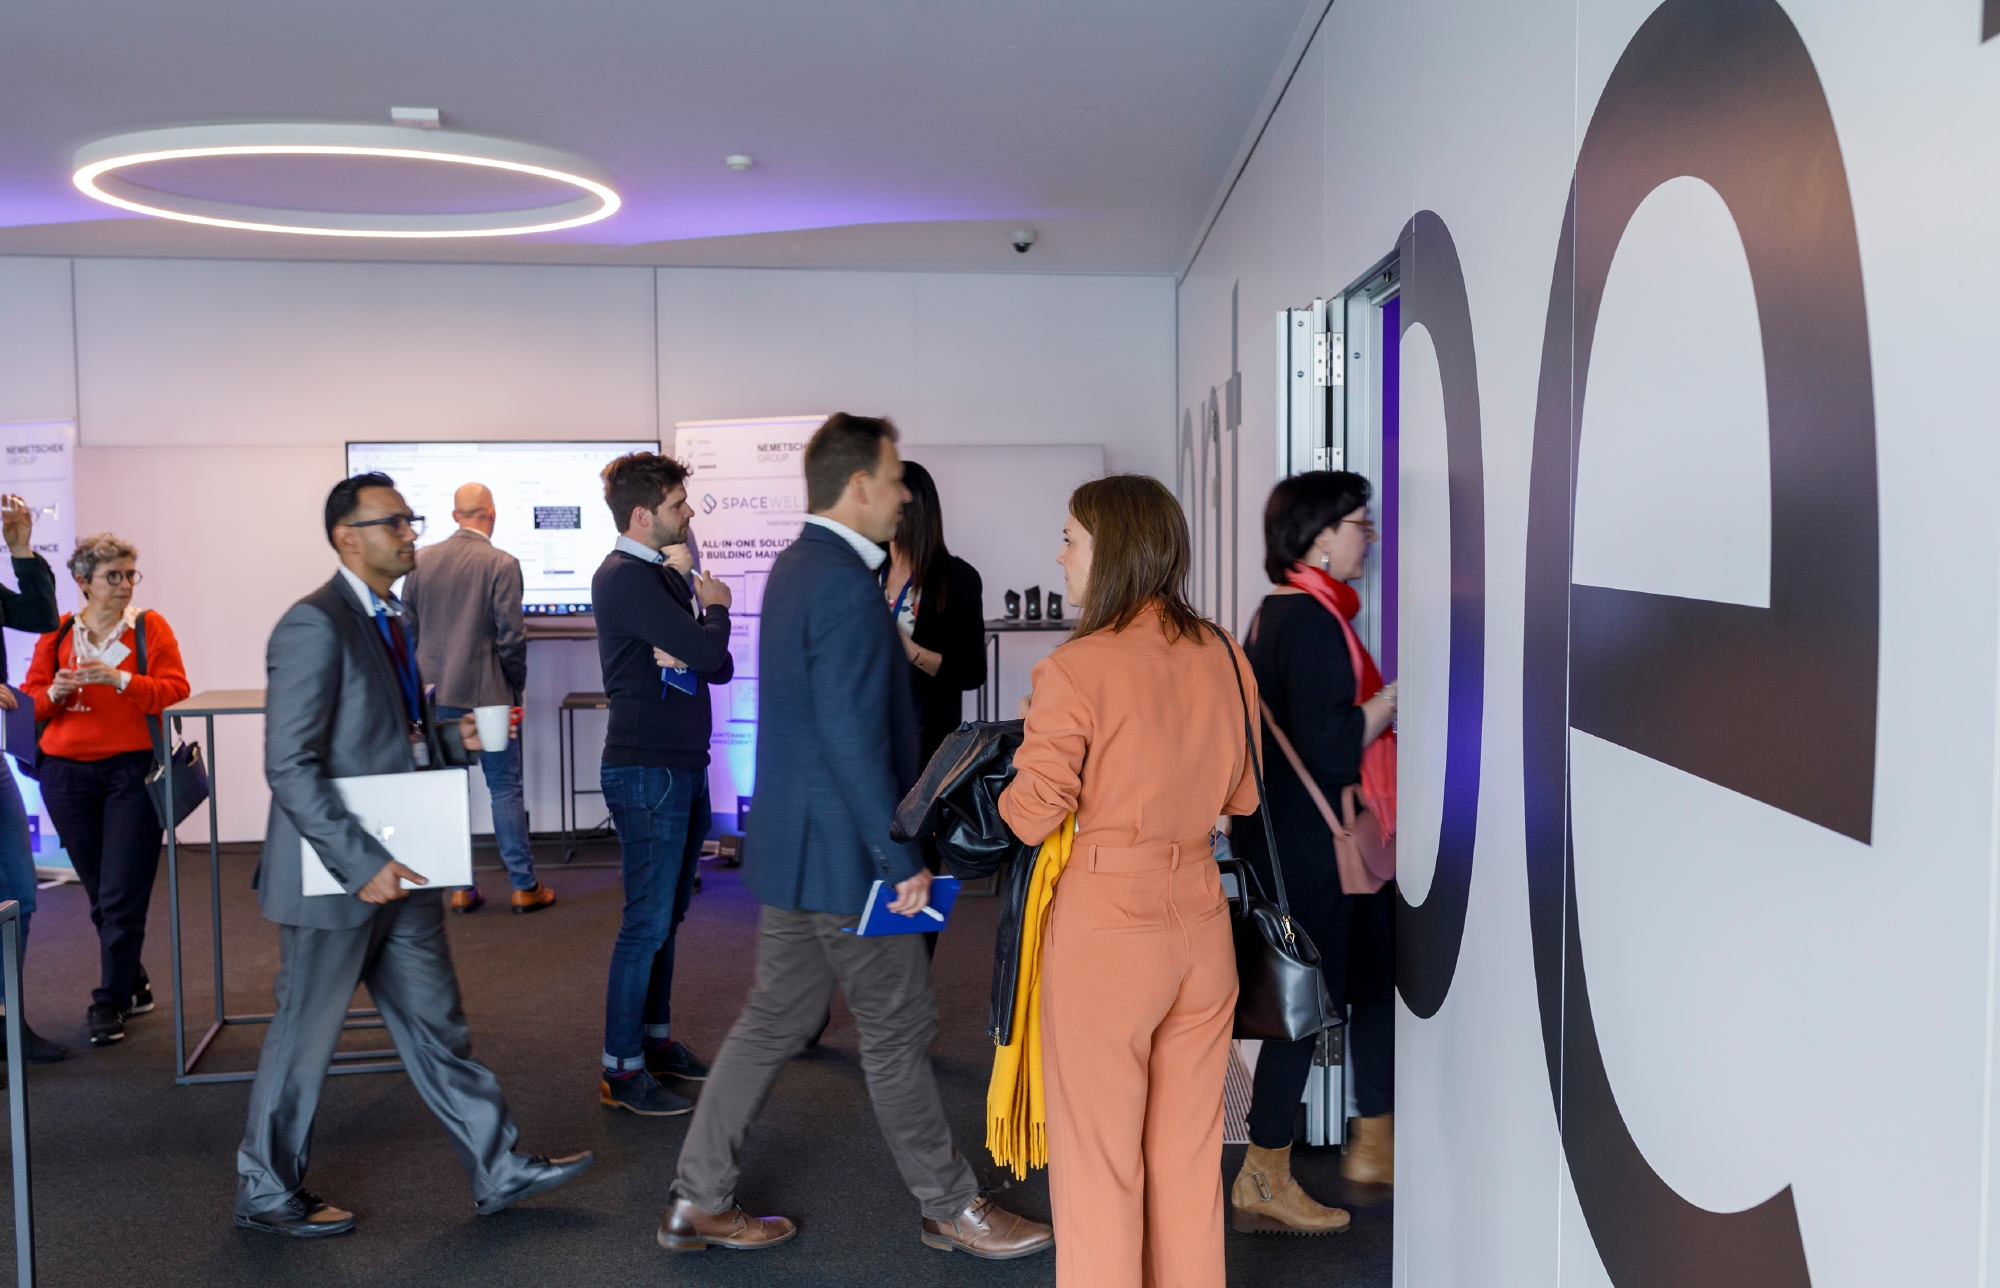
left=882, top=460, right=986, bottom=804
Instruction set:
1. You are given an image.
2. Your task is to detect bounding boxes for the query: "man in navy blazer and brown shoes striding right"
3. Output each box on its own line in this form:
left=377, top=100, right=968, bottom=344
left=658, top=414, right=1054, bottom=1258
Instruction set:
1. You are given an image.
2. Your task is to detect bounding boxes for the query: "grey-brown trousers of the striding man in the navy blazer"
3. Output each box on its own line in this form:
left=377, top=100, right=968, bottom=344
left=674, top=908, right=980, bottom=1220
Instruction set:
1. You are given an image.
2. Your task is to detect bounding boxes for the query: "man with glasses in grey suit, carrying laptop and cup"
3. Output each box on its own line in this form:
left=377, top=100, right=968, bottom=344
left=236, top=474, right=592, bottom=1238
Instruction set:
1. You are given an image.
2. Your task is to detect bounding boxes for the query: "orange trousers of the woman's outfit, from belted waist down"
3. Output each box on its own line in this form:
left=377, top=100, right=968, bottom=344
left=1042, top=838, right=1236, bottom=1288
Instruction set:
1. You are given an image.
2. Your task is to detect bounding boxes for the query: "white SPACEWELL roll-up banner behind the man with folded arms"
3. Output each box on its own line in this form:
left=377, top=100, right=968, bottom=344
left=674, top=416, right=826, bottom=830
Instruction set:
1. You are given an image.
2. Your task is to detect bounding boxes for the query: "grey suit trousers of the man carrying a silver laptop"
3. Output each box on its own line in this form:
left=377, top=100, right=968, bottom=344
left=236, top=890, right=526, bottom=1216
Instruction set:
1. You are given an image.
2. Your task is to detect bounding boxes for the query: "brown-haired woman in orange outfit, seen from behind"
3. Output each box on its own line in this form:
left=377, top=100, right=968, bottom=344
left=1000, top=474, right=1256, bottom=1288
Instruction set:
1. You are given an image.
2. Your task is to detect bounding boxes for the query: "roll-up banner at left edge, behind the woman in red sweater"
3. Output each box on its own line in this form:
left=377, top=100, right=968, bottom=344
left=0, top=420, right=76, bottom=876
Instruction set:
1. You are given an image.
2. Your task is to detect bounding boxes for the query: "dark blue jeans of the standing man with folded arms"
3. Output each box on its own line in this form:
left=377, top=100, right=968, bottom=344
left=600, top=764, right=708, bottom=1070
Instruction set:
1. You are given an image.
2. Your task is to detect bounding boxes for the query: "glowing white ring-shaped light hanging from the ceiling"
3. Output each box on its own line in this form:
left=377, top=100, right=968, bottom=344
left=74, top=124, right=622, bottom=238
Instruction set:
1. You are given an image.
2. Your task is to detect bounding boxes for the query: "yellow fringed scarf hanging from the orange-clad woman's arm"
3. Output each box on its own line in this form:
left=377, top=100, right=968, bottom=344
left=986, top=814, right=1076, bottom=1180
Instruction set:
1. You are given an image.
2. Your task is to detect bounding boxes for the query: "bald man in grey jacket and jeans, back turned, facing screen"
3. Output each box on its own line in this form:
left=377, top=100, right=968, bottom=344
left=402, top=484, right=556, bottom=912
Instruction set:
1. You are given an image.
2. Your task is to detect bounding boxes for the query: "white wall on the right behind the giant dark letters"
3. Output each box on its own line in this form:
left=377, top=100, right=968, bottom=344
left=1180, top=0, right=2000, bottom=1288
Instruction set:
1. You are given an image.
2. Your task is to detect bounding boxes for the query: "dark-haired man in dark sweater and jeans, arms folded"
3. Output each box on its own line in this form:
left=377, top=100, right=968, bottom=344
left=590, top=452, right=736, bottom=1116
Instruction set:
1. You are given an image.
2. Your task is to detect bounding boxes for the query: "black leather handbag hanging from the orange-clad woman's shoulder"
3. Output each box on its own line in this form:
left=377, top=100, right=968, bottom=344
left=1210, top=624, right=1346, bottom=1042
